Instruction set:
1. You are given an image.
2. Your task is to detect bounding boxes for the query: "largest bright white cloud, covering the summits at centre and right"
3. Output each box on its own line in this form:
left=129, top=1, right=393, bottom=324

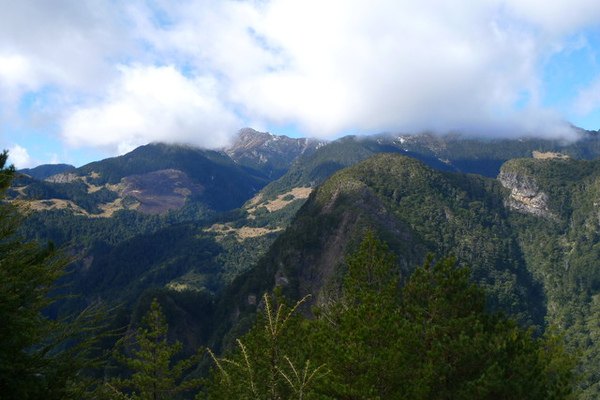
left=130, top=0, right=598, bottom=136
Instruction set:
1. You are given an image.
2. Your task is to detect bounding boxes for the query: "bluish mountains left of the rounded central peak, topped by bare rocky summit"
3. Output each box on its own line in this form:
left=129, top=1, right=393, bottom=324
left=11, top=130, right=317, bottom=320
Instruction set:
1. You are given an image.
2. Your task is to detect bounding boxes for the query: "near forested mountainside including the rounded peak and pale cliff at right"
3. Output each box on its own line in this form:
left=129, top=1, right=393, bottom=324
left=221, top=154, right=600, bottom=398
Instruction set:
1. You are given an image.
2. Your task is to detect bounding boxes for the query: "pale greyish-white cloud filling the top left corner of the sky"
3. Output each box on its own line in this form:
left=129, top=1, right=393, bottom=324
left=0, top=0, right=127, bottom=96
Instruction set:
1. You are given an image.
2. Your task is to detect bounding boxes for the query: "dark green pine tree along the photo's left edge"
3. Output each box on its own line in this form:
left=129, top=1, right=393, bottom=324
left=0, top=151, right=106, bottom=399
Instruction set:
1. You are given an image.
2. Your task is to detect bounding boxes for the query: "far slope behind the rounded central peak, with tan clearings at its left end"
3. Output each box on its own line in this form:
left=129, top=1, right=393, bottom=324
left=205, top=131, right=600, bottom=290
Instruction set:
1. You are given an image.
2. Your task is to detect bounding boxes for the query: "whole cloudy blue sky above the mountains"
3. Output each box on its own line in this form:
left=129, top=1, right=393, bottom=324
left=0, top=0, right=600, bottom=168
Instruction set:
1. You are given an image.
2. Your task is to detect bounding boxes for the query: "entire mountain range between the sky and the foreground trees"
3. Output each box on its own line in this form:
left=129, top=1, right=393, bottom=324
left=10, top=129, right=600, bottom=398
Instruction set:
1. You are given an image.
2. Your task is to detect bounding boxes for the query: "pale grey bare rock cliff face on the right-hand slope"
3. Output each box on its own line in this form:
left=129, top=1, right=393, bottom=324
left=498, top=167, right=555, bottom=218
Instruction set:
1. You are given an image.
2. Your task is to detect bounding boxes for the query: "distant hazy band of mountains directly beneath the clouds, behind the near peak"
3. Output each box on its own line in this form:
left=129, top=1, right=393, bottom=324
left=13, top=128, right=600, bottom=220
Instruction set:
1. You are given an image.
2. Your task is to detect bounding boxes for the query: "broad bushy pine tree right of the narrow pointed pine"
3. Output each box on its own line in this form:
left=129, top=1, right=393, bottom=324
left=401, top=257, right=575, bottom=400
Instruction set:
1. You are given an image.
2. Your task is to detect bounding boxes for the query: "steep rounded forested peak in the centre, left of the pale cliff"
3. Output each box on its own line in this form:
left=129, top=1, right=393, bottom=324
left=220, top=154, right=544, bottom=329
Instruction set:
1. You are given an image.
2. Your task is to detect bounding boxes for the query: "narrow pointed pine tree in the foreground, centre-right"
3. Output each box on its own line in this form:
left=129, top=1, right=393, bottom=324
left=311, top=230, right=410, bottom=398
